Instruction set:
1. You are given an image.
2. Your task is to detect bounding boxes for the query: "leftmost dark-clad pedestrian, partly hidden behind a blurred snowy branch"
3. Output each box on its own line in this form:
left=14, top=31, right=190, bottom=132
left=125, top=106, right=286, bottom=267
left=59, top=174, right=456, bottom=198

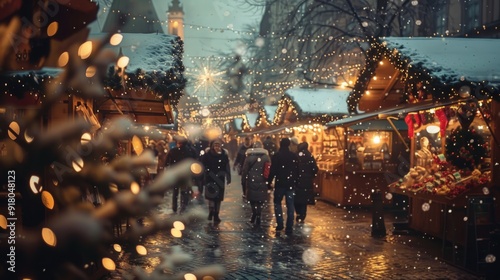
left=165, top=136, right=198, bottom=214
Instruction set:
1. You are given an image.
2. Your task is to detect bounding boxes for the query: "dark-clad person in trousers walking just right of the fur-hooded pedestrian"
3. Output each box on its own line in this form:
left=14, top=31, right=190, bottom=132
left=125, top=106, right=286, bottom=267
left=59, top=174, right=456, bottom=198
left=267, top=138, right=299, bottom=234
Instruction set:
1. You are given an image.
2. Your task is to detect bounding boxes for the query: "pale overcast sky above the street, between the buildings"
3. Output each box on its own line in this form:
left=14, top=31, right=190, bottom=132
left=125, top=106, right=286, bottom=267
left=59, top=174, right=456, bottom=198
left=91, top=0, right=263, bottom=103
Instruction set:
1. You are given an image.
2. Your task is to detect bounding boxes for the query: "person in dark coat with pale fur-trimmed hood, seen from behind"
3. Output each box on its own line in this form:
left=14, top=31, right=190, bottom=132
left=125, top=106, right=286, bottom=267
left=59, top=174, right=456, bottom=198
left=241, top=141, right=271, bottom=225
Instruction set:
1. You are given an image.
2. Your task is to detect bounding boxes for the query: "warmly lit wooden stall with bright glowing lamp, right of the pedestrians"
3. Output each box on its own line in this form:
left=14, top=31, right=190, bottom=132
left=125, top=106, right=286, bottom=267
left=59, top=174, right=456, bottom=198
left=318, top=110, right=407, bottom=206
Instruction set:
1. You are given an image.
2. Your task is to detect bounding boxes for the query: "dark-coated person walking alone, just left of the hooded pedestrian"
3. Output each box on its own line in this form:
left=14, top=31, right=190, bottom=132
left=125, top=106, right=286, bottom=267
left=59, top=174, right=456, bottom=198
left=201, top=139, right=231, bottom=223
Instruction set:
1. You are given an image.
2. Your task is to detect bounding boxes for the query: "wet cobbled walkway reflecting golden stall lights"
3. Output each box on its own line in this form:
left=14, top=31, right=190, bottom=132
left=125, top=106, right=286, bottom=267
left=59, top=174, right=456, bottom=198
left=109, top=170, right=488, bottom=280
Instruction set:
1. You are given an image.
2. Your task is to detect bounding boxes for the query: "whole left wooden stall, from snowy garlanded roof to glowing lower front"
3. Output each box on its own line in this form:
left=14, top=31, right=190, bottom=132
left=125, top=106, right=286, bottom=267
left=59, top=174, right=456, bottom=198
left=88, top=33, right=186, bottom=178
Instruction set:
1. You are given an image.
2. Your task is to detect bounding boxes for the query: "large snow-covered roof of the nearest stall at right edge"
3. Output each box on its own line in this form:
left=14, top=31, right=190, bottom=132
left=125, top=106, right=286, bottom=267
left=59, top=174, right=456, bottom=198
left=382, top=37, right=500, bottom=85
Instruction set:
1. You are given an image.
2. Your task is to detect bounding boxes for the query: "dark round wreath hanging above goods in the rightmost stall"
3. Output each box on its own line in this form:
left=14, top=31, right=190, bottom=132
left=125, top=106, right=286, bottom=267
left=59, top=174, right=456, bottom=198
left=446, top=127, right=486, bottom=171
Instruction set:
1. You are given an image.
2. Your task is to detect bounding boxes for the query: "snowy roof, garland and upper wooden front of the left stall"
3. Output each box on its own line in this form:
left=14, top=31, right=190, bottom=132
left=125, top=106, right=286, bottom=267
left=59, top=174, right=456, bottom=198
left=95, top=33, right=186, bottom=128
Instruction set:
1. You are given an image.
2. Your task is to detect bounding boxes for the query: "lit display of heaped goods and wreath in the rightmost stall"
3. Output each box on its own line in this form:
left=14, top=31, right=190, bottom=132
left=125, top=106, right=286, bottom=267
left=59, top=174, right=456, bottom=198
left=395, top=104, right=491, bottom=198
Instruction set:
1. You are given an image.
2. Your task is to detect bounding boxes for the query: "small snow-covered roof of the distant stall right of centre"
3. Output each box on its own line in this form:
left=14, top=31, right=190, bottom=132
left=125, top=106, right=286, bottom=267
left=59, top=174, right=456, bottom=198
left=285, top=88, right=351, bottom=115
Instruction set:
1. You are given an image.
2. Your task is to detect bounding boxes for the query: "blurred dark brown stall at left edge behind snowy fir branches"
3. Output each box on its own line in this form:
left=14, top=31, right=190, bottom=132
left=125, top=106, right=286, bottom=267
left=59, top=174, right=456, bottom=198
left=0, top=1, right=101, bottom=232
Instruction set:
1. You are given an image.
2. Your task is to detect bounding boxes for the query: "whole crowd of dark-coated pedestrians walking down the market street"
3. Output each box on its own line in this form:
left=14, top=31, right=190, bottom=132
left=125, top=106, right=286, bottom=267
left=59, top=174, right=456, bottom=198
left=150, top=133, right=318, bottom=234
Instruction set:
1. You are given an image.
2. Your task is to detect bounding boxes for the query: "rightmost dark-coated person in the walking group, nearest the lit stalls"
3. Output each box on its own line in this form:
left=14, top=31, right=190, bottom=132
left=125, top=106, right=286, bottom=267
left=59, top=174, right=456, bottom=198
left=294, top=142, right=318, bottom=223
